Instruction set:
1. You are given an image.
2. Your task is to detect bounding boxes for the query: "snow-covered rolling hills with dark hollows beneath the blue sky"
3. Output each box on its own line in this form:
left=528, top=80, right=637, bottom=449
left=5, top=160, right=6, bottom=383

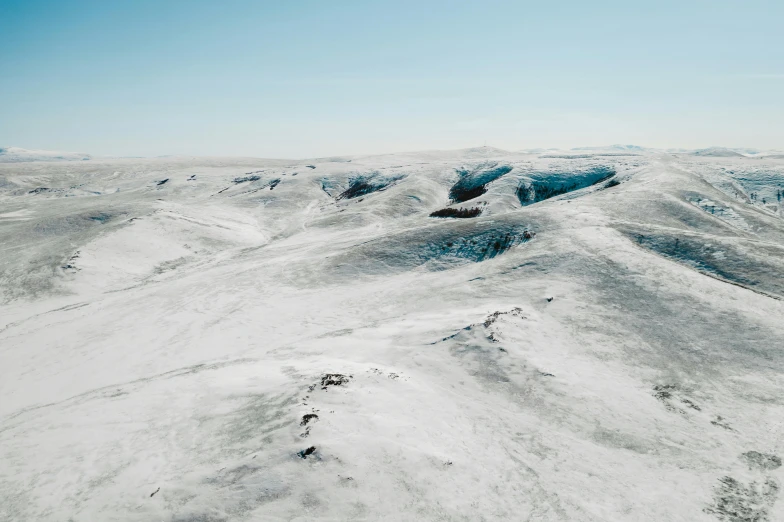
left=0, top=146, right=784, bottom=522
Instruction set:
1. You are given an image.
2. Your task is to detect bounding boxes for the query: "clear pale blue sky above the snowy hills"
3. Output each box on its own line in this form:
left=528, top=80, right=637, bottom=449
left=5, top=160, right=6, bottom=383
left=0, top=0, right=784, bottom=158
